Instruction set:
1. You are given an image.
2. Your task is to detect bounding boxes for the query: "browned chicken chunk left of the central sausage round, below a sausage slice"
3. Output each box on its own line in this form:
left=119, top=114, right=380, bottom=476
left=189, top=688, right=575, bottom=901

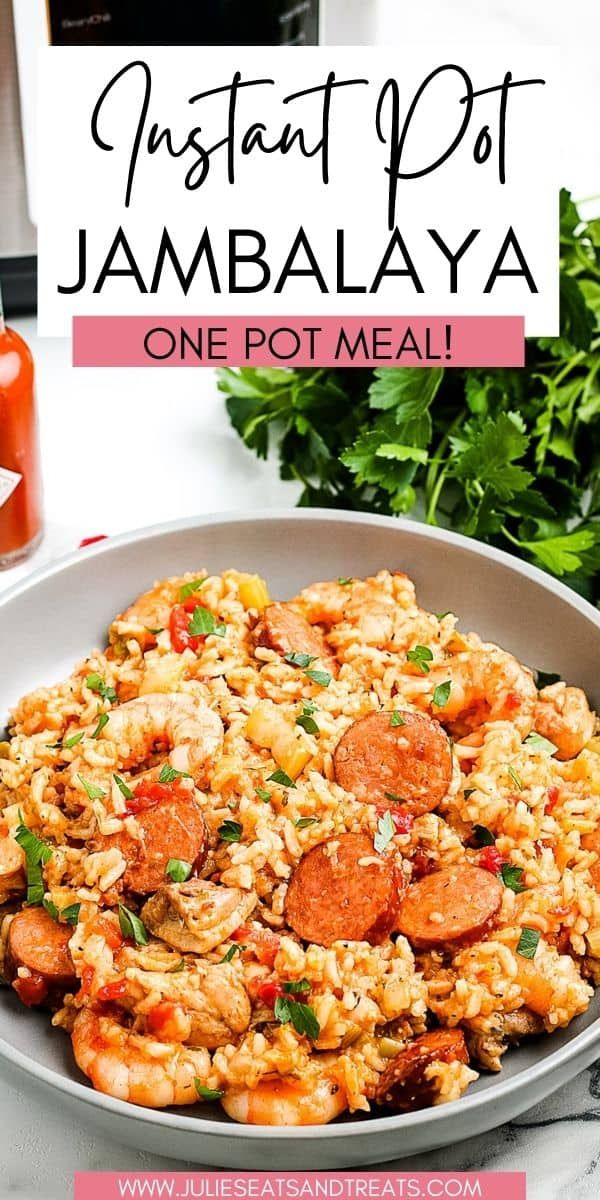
left=142, top=880, right=258, bottom=954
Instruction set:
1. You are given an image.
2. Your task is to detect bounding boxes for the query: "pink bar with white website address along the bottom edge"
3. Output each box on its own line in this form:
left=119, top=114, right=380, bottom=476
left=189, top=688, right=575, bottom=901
left=74, top=1169, right=526, bottom=1200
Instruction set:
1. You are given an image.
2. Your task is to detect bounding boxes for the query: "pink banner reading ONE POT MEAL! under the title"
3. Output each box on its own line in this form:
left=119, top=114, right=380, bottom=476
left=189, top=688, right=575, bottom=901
left=73, top=317, right=524, bottom=367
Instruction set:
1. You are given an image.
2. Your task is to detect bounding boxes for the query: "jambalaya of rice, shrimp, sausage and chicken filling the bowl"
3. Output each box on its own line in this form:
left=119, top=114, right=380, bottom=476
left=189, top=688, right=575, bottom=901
left=0, top=570, right=600, bottom=1126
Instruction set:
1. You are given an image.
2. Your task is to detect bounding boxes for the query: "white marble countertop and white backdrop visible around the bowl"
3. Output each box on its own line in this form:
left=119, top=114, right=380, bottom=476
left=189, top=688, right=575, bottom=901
left=0, top=0, right=600, bottom=1200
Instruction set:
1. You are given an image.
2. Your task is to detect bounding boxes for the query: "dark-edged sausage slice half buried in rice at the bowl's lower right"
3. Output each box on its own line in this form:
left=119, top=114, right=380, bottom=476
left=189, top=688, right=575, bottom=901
left=372, top=1030, right=469, bottom=1112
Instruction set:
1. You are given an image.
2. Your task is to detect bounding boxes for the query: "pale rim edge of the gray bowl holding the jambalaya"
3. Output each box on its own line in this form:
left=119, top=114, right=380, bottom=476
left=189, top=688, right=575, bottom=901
left=0, top=508, right=600, bottom=1141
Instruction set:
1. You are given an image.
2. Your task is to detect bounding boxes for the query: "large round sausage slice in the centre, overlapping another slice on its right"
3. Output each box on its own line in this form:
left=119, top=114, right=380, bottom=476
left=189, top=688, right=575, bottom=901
left=286, top=833, right=404, bottom=946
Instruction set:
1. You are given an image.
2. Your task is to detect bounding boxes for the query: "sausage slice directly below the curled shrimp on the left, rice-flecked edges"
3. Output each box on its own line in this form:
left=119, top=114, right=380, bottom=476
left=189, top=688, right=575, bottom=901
left=97, top=793, right=208, bottom=895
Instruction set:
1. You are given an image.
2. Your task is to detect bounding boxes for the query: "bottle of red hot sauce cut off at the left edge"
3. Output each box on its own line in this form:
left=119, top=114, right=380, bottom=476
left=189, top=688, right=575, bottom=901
left=0, top=298, right=42, bottom=569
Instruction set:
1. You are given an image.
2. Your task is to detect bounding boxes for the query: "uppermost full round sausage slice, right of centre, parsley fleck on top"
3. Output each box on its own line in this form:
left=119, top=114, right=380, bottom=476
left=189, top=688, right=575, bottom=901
left=334, top=709, right=452, bottom=816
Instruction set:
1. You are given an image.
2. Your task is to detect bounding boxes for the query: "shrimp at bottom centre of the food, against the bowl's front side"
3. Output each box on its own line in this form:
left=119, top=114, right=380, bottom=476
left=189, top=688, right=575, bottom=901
left=221, top=1055, right=348, bottom=1126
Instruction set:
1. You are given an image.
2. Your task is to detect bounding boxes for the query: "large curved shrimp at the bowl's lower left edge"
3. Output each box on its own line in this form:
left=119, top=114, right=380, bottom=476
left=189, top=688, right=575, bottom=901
left=71, top=1008, right=211, bottom=1109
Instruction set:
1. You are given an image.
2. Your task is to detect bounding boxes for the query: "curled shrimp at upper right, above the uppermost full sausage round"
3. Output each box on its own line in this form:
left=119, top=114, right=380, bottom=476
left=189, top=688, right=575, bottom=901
left=402, top=646, right=538, bottom=738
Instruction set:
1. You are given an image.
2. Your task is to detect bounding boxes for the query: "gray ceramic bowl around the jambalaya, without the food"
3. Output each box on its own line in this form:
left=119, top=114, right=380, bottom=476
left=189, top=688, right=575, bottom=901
left=0, top=510, right=600, bottom=1170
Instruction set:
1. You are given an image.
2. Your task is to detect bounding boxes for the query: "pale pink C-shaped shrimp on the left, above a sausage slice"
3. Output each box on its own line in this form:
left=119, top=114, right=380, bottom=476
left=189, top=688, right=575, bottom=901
left=76, top=692, right=223, bottom=787
